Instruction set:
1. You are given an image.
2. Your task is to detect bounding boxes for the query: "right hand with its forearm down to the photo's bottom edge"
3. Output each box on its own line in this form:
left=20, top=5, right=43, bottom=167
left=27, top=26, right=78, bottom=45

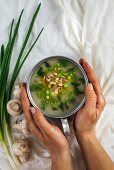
left=74, top=59, right=114, bottom=170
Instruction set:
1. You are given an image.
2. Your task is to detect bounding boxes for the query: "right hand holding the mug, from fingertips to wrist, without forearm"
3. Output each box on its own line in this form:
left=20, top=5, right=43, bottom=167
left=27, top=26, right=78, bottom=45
left=74, top=59, right=106, bottom=140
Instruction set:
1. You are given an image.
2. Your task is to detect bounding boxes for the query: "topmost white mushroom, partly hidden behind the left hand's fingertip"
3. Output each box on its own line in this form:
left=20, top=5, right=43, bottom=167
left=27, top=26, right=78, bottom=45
left=13, top=83, right=21, bottom=99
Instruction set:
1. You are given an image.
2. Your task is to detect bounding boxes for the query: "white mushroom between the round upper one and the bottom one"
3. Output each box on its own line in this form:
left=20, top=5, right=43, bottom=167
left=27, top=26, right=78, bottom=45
left=12, top=119, right=29, bottom=135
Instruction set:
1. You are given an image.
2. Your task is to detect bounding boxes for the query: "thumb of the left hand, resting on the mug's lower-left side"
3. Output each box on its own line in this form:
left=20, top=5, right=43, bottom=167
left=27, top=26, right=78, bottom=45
left=30, top=107, right=53, bottom=134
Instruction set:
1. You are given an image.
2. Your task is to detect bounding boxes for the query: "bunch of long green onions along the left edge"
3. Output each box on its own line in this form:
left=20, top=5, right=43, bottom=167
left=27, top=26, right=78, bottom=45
left=0, top=3, right=43, bottom=170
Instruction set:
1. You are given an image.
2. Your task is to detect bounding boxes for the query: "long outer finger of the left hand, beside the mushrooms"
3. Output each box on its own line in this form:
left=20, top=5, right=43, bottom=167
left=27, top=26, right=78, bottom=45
left=21, top=83, right=43, bottom=140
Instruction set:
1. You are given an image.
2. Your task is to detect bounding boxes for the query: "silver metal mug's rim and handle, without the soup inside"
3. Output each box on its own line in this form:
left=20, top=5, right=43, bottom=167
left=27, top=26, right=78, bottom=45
left=27, top=56, right=88, bottom=134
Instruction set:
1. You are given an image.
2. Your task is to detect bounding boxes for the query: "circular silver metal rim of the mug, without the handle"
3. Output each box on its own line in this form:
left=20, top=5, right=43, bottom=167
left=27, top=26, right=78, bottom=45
left=27, top=55, right=89, bottom=119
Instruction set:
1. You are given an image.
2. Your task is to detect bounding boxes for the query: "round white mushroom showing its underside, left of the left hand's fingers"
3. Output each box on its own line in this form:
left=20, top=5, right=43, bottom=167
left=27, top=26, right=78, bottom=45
left=7, top=99, right=22, bottom=116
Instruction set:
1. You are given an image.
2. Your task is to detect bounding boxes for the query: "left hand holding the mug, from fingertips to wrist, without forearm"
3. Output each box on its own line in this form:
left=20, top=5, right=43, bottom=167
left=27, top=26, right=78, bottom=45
left=21, top=84, right=70, bottom=160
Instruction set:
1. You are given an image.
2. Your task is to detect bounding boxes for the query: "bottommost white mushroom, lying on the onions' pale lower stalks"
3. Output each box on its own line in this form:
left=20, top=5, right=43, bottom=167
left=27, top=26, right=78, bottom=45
left=12, top=139, right=30, bottom=157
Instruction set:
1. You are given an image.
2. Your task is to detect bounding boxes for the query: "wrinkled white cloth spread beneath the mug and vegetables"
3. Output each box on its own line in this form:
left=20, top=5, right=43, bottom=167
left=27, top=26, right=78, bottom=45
left=0, top=0, right=114, bottom=170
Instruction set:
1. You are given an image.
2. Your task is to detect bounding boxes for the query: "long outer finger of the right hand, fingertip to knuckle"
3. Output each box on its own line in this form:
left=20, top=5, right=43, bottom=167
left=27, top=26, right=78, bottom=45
left=80, top=58, right=106, bottom=111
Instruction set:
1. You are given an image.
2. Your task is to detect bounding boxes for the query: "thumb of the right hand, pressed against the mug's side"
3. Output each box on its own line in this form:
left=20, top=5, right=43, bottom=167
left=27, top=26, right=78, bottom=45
left=85, top=83, right=97, bottom=108
